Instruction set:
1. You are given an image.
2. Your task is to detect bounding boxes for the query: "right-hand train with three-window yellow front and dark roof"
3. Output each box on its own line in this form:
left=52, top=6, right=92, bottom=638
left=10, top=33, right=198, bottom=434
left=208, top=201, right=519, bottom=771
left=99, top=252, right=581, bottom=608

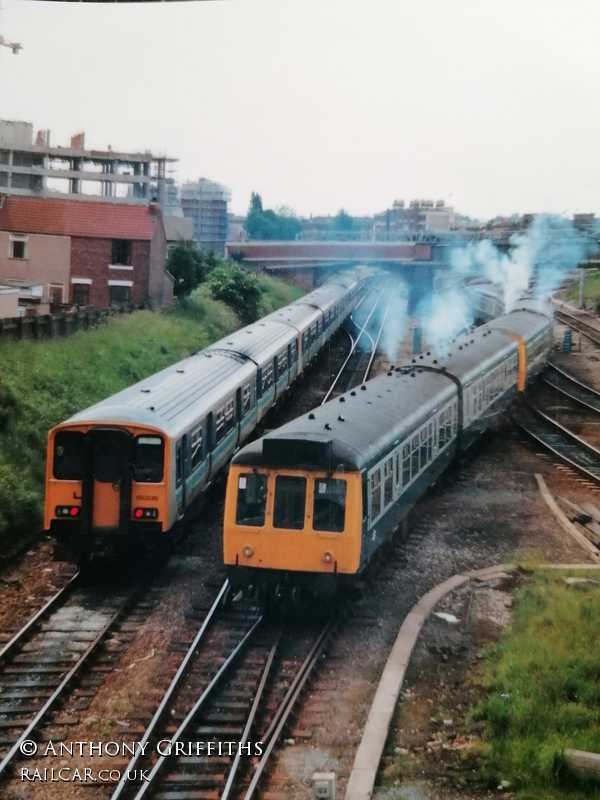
left=224, top=301, right=552, bottom=595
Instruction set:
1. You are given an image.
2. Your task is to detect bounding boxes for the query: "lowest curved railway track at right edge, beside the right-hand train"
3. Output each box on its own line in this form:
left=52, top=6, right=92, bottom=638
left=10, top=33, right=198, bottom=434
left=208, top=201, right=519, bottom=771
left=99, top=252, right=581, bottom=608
left=513, top=402, right=600, bottom=485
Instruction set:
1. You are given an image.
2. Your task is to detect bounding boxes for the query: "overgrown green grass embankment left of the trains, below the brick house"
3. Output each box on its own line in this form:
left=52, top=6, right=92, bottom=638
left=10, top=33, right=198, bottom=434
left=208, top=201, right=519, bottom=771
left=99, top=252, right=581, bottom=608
left=0, top=278, right=300, bottom=542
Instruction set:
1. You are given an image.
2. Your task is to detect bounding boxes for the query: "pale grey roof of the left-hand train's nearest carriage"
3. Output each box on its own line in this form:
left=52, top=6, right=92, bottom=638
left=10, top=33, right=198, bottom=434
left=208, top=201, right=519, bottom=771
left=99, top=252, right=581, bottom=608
left=63, top=350, right=255, bottom=436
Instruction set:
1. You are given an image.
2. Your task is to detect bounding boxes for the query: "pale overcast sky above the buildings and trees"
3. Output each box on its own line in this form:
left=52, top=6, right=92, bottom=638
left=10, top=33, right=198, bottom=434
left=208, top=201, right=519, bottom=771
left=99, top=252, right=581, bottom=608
left=0, top=0, right=600, bottom=217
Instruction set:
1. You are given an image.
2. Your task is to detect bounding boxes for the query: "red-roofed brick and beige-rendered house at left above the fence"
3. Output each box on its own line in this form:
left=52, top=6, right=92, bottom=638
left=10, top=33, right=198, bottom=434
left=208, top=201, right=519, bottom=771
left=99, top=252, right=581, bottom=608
left=0, top=195, right=173, bottom=310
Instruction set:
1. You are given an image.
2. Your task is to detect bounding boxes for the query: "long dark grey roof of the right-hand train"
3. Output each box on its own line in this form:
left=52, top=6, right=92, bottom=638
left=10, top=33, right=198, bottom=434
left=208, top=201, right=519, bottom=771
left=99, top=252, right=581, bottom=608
left=233, top=310, right=548, bottom=471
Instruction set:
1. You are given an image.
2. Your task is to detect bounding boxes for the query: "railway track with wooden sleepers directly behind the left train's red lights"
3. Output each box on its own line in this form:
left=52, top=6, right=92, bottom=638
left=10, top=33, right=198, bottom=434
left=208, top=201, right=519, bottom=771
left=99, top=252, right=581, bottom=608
left=0, top=574, right=151, bottom=779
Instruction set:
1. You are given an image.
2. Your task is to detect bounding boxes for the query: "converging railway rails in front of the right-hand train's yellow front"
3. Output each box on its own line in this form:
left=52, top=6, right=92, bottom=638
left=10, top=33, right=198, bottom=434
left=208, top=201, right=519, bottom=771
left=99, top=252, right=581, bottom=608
left=111, top=582, right=335, bottom=800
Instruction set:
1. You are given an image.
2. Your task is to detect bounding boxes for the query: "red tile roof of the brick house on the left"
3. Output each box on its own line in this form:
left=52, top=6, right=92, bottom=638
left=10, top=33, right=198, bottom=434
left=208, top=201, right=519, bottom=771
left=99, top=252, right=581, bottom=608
left=0, top=195, right=157, bottom=240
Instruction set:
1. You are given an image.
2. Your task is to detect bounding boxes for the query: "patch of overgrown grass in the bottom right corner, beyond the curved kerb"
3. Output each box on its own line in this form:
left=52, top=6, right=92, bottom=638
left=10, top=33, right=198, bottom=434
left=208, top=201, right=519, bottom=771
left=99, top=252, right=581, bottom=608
left=474, top=571, right=600, bottom=800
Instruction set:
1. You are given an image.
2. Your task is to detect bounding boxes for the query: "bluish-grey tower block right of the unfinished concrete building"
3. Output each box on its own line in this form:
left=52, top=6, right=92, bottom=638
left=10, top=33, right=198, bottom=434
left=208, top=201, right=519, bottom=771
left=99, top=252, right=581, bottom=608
left=180, top=178, right=231, bottom=255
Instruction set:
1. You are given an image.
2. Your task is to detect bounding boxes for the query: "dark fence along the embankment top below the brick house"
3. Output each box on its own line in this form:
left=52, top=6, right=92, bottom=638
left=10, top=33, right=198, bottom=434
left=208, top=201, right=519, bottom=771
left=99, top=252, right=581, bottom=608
left=0, top=308, right=131, bottom=340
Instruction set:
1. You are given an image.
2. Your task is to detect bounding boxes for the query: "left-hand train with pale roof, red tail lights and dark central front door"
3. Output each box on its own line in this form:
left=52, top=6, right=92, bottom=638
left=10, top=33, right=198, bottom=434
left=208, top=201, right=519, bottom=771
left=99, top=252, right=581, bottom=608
left=45, top=273, right=365, bottom=562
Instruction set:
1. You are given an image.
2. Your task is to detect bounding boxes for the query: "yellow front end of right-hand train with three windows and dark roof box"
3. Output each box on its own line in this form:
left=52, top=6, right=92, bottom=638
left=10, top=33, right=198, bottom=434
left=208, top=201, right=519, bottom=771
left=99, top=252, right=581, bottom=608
left=224, top=436, right=362, bottom=598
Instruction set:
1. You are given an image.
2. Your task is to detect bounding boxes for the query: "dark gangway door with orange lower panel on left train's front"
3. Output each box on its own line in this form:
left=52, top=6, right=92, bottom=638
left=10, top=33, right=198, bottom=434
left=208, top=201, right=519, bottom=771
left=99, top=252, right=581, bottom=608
left=83, top=428, right=134, bottom=533
